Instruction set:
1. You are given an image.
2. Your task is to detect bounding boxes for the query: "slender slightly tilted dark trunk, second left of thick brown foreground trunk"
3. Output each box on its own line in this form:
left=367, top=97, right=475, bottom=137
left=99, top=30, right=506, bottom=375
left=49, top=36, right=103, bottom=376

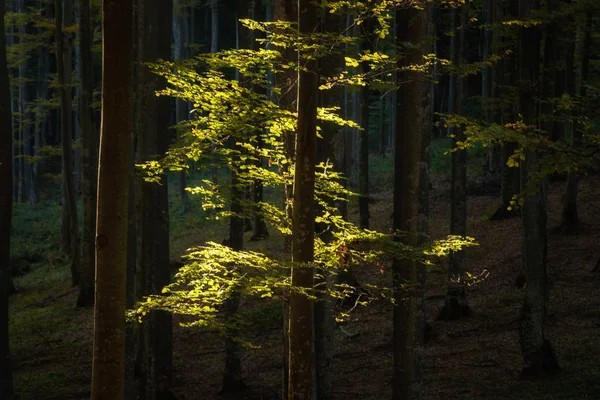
left=54, top=0, right=81, bottom=286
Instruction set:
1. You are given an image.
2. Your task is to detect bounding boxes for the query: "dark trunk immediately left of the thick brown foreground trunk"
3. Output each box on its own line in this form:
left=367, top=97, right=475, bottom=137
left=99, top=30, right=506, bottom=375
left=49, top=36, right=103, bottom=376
left=77, top=0, right=98, bottom=307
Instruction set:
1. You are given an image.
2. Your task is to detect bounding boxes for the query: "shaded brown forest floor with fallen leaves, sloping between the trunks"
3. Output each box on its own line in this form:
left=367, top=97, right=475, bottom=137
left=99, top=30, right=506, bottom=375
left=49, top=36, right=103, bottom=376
left=10, top=173, right=600, bottom=400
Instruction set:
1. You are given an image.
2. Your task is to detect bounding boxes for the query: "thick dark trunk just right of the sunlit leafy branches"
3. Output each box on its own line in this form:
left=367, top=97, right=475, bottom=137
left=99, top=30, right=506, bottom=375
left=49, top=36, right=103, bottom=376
left=392, top=4, right=429, bottom=400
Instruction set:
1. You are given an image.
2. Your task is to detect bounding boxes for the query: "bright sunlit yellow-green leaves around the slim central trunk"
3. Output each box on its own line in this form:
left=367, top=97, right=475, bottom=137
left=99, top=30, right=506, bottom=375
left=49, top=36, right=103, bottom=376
left=128, top=9, right=474, bottom=331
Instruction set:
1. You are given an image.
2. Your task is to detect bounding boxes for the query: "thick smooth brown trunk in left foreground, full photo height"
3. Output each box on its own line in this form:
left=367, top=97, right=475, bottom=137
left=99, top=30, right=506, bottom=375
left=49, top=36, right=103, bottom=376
left=91, top=0, right=133, bottom=400
